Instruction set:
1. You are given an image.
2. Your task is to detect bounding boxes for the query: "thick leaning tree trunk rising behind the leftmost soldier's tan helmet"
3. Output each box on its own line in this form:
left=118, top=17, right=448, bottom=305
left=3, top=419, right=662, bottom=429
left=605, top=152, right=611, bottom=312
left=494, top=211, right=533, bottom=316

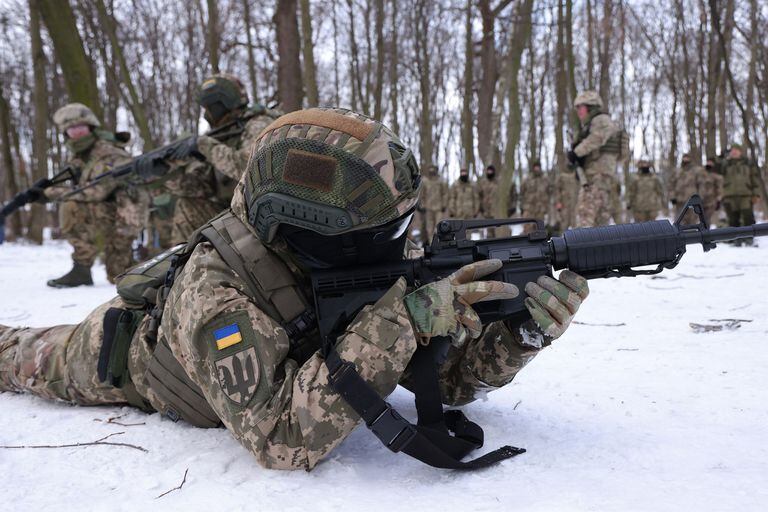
left=38, top=0, right=104, bottom=119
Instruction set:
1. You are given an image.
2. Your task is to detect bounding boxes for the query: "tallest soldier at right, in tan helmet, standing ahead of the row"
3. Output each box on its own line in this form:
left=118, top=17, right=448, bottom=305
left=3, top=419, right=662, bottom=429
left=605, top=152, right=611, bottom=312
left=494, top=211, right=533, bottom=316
left=568, top=91, right=620, bottom=226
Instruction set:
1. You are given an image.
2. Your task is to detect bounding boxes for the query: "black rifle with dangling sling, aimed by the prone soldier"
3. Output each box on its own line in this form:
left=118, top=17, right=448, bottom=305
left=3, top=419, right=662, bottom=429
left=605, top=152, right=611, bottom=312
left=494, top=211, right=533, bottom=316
left=312, top=196, right=768, bottom=469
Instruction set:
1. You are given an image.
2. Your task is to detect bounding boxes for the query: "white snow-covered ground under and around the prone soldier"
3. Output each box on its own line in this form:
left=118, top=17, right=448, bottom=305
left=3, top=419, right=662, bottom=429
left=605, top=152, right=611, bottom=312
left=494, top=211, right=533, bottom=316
left=0, top=233, right=768, bottom=512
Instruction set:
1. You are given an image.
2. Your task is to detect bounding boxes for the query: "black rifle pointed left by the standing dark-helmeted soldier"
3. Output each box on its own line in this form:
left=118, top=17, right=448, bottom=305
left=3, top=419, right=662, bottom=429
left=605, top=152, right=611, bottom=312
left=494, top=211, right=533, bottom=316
left=58, top=111, right=253, bottom=201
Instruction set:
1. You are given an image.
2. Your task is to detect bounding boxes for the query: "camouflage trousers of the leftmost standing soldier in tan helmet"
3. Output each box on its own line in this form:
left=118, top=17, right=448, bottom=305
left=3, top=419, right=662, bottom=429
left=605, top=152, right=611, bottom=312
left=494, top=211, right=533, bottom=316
left=59, top=196, right=147, bottom=282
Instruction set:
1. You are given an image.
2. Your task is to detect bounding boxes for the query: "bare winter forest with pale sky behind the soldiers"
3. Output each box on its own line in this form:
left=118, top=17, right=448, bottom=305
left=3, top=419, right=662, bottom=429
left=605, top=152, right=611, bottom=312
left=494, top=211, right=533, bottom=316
left=0, top=0, right=768, bottom=240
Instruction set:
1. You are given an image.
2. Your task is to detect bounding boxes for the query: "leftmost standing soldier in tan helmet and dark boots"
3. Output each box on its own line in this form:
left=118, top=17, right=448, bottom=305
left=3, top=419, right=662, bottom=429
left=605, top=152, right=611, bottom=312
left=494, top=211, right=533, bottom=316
left=45, top=103, right=147, bottom=288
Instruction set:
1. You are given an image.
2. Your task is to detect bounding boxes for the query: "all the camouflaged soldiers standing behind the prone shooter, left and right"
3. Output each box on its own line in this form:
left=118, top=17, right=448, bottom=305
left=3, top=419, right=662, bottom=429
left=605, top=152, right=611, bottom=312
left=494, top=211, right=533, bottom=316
left=34, top=84, right=760, bottom=287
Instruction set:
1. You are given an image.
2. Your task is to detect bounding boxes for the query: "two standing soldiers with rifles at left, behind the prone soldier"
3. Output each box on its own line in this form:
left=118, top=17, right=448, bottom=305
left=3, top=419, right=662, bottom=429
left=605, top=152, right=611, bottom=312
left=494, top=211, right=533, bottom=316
left=37, top=74, right=279, bottom=288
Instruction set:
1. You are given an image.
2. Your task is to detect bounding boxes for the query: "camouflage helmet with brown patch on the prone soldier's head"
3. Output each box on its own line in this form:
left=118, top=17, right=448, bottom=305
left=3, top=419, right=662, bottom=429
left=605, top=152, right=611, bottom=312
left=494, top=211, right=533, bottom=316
left=241, top=108, right=421, bottom=242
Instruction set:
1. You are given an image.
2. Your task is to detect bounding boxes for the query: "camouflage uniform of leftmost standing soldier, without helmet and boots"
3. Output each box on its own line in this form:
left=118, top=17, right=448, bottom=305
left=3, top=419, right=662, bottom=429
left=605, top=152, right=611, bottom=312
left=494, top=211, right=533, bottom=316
left=45, top=139, right=150, bottom=282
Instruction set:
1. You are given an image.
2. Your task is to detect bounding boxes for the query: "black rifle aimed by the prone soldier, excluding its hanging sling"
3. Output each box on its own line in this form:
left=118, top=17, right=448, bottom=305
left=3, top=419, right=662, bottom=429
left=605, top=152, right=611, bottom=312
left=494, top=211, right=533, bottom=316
left=312, top=195, right=768, bottom=337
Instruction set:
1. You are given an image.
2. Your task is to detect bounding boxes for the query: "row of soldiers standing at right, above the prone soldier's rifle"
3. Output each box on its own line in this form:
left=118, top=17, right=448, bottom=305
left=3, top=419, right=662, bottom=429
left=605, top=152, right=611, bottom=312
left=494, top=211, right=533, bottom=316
left=413, top=91, right=761, bottom=243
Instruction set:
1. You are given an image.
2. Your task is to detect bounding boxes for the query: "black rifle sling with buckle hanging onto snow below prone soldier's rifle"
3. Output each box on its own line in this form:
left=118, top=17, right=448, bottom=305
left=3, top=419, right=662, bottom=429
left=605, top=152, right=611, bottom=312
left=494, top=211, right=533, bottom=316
left=325, top=343, right=525, bottom=469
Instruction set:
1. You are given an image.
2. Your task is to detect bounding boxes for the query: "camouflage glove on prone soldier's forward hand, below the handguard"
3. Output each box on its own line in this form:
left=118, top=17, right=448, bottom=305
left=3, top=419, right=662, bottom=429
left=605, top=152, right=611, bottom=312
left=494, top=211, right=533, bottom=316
left=521, top=270, right=589, bottom=342
